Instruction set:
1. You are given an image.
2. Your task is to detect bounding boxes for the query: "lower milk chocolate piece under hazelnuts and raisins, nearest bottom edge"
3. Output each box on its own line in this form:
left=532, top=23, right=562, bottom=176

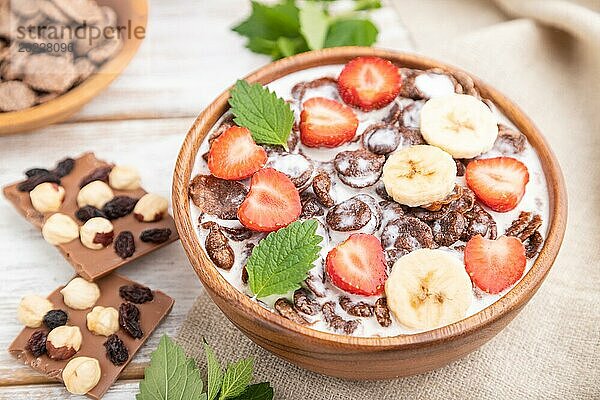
left=8, top=274, right=174, bottom=399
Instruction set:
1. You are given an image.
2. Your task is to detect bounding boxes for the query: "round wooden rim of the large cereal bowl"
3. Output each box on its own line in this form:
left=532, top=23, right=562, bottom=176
left=172, top=47, right=567, bottom=351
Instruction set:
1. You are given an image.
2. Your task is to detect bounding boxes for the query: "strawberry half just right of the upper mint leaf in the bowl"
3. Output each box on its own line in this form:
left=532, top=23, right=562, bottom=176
left=300, top=97, right=358, bottom=147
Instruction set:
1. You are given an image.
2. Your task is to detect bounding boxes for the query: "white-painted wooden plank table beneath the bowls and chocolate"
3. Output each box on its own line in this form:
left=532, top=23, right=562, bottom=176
left=0, top=0, right=411, bottom=400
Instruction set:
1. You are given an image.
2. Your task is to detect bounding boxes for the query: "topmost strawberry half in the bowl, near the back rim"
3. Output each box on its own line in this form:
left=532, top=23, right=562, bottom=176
left=338, top=57, right=401, bottom=111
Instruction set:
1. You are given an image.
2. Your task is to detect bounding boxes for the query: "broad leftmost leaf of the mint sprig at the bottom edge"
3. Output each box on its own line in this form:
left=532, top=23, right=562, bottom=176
left=136, top=335, right=206, bottom=400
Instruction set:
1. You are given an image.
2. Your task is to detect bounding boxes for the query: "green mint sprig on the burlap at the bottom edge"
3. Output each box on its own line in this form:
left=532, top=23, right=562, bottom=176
left=136, top=335, right=274, bottom=400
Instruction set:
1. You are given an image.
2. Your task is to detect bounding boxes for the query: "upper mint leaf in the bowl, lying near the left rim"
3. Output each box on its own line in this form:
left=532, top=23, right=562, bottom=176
left=229, top=80, right=294, bottom=149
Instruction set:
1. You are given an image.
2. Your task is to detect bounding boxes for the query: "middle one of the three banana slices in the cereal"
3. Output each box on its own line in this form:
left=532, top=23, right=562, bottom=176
left=383, top=145, right=456, bottom=207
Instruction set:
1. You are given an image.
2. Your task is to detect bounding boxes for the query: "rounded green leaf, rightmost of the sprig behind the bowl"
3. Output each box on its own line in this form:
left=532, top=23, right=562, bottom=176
left=325, top=19, right=378, bottom=47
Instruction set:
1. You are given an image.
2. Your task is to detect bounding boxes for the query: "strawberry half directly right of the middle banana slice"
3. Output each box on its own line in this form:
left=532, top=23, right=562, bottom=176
left=465, top=157, right=529, bottom=212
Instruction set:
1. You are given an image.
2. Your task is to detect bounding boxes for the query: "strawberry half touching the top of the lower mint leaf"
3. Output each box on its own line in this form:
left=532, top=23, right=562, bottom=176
left=238, top=168, right=302, bottom=232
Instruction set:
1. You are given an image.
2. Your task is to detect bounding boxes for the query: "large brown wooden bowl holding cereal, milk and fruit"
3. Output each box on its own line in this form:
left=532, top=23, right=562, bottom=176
left=173, top=47, right=567, bottom=380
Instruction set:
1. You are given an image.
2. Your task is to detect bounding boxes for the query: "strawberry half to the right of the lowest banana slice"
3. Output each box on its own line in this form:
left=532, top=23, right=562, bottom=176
left=465, top=235, right=527, bottom=293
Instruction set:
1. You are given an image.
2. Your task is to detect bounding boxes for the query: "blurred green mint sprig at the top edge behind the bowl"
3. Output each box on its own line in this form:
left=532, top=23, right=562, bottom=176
left=233, top=0, right=381, bottom=60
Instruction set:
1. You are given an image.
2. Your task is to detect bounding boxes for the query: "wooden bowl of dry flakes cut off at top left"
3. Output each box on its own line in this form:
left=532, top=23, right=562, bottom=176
left=0, top=0, right=148, bottom=136
